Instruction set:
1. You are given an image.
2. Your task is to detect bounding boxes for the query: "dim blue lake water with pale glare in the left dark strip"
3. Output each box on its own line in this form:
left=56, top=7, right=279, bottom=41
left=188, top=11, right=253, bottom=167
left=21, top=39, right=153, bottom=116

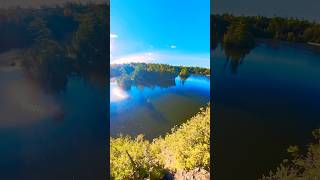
left=0, top=50, right=109, bottom=180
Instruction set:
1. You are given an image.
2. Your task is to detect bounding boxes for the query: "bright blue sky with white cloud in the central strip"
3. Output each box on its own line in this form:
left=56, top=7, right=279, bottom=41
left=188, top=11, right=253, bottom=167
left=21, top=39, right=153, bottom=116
left=110, top=0, right=210, bottom=67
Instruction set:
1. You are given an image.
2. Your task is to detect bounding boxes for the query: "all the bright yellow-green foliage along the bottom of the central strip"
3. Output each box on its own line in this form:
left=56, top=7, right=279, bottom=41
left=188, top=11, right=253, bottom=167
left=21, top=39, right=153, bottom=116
left=110, top=107, right=210, bottom=180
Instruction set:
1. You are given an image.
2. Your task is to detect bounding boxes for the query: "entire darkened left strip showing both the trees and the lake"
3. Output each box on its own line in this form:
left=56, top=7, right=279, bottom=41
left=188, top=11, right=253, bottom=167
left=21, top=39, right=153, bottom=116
left=0, top=1, right=110, bottom=180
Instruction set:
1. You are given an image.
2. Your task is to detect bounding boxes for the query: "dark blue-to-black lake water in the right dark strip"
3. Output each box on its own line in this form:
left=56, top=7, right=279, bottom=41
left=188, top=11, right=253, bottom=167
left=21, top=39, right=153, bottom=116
left=211, top=41, right=320, bottom=179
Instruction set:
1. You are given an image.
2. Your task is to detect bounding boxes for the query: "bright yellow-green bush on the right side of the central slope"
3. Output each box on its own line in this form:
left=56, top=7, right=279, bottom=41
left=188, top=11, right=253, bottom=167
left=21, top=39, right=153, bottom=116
left=153, top=107, right=210, bottom=171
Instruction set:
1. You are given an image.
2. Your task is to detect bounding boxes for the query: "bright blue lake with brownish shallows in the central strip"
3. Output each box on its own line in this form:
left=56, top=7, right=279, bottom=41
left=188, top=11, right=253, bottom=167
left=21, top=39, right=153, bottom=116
left=110, top=75, right=210, bottom=140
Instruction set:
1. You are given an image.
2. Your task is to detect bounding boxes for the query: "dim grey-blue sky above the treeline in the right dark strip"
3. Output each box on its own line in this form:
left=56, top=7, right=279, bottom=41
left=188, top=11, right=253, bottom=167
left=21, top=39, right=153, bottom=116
left=211, top=0, right=320, bottom=22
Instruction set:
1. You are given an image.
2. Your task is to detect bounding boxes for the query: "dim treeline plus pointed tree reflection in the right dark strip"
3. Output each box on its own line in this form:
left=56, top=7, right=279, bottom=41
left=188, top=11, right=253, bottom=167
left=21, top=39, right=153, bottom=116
left=210, top=14, right=320, bottom=74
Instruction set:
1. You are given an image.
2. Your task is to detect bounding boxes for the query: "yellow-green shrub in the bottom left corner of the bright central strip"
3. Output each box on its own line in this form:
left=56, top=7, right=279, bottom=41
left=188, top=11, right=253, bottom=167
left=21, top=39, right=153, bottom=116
left=110, top=135, right=164, bottom=180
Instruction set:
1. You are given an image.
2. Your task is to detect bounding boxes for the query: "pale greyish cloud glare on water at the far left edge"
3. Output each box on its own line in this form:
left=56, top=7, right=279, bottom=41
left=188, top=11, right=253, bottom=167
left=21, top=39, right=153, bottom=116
left=0, top=63, right=61, bottom=128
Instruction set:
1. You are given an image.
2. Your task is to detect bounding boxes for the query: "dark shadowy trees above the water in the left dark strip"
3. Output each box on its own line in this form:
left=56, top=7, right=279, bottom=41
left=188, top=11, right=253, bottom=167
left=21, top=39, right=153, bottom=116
left=0, top=3, right=109, bottom=91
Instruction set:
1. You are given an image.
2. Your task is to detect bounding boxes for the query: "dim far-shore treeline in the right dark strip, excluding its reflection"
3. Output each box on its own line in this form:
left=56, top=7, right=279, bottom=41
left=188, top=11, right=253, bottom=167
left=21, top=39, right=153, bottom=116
left=211, top=14, right=320, bottom=47
